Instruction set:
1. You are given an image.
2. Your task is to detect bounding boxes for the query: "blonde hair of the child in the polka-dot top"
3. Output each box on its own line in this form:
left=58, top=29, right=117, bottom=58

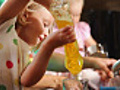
left=16, top=1, right=45, bottom=28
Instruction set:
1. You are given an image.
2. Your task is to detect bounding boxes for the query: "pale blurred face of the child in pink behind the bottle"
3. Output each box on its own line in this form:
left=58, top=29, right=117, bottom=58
left=70, top=2, right=83, bottom=23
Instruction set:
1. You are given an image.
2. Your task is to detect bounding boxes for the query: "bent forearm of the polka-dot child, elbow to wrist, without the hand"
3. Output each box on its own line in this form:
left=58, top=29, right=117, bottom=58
left=21, top=40, right=54, bottom=87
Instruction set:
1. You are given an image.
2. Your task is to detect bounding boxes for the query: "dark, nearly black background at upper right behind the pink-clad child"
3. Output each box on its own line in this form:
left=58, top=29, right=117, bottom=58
left=82, top=0, right=120, bottom=59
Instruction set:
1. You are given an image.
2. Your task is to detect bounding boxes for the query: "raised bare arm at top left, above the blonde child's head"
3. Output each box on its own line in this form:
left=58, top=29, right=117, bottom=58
left=0, top=0, right=52, bottom=25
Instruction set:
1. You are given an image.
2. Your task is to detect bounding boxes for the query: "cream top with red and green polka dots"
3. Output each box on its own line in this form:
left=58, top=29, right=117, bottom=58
left=0, top=18, right=31, bottom=90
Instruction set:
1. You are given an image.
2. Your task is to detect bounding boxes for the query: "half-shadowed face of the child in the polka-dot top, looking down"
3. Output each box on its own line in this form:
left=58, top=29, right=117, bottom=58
left=19, top=9, right=54, bottom=46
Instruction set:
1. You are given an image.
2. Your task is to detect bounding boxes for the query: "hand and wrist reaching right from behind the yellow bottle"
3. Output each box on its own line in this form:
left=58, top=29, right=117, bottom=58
left=84, top=57, right=117, bottom=77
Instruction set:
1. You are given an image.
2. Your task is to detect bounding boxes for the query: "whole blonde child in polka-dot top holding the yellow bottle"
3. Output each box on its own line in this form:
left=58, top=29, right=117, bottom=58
left=0, top=0, right=75, bottom=90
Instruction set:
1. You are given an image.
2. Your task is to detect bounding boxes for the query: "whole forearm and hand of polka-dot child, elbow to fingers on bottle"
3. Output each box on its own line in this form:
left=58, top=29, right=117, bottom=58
left=21, top=27, right=76, bottom=86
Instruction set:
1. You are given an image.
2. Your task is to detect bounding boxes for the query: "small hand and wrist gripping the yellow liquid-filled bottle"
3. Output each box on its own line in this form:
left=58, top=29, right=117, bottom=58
left=47, top=26, right=76, bottom=48
